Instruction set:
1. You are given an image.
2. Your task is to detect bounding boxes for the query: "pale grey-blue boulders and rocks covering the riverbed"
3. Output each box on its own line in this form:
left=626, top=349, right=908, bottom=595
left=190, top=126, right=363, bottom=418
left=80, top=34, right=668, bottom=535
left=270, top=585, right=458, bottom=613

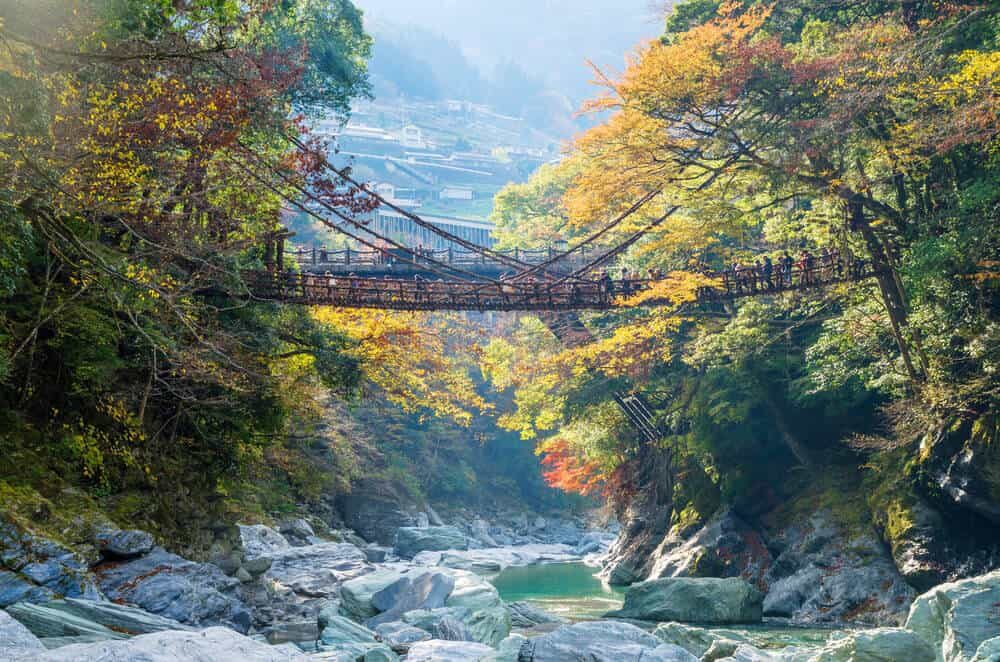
left=0, top=516, right=1000, bottom=662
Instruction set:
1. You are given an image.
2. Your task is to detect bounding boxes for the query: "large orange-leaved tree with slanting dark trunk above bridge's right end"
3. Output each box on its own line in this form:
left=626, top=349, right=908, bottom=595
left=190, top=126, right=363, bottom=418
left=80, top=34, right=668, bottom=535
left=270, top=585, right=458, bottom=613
left=567, top=4, right=996, bottom=390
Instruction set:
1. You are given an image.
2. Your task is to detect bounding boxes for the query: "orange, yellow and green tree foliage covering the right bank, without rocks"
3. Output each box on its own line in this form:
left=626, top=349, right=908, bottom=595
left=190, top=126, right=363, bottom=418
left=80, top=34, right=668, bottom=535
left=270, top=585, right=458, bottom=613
left=485, top=0, right=998, bottom=500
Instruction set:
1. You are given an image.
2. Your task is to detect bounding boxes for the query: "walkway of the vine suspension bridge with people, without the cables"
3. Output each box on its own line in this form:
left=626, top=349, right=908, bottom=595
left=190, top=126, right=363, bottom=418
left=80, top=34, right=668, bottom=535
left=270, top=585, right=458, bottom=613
left=245, top=265, right=874, bottom=311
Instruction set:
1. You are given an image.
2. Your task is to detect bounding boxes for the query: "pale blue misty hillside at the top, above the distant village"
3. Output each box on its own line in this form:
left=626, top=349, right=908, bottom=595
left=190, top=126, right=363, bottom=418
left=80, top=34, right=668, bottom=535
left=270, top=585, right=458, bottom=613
left=358, top=0, right=662, bottom=112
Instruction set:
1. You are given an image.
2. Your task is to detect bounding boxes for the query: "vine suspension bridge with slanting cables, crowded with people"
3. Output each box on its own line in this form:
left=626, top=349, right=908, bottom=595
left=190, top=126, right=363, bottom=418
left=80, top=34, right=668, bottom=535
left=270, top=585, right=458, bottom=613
left=244, top=148, right=875, bottom=313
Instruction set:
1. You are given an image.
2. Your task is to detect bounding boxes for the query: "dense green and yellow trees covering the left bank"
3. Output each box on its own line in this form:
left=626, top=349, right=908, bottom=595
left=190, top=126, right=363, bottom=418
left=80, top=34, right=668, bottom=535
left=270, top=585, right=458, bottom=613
left=0, top=0, right=376, bottom=536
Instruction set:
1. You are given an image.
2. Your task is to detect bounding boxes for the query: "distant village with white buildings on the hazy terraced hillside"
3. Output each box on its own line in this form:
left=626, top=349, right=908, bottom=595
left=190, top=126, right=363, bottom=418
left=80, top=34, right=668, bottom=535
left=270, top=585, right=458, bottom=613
left=295, top=100, right=560, bottom=249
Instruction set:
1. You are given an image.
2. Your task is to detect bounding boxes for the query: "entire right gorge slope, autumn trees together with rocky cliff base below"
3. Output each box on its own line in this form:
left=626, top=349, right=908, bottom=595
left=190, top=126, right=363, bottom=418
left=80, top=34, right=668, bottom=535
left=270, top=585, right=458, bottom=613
left=485, top=0, right=1000, bottom=617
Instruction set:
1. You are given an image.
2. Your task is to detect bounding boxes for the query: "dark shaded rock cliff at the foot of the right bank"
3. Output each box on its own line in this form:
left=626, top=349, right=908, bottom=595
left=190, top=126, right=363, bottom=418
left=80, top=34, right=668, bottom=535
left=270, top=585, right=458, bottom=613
left=603, top=417, right=1000, bottom=624
